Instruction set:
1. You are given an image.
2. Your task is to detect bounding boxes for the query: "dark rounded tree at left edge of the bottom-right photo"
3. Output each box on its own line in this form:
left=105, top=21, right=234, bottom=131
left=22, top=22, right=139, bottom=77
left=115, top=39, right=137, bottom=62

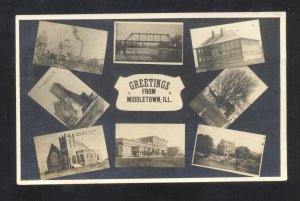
left=196, top=134, right=214, bottom=155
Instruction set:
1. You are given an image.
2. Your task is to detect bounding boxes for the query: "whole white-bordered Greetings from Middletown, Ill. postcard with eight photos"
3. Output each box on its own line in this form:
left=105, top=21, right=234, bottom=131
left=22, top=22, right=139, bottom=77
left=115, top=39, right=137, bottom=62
left=15, top=12, right=287, bottom=185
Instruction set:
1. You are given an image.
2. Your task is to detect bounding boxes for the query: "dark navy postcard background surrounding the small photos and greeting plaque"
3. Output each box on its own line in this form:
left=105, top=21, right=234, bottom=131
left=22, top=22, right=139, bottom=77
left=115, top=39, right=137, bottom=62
left=19, top=18, right=280, bottom=180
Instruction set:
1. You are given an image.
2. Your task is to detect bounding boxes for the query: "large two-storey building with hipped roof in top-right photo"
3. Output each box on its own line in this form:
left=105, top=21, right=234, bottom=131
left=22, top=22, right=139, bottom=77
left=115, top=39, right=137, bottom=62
left=195, top=28, right=264, bottom=69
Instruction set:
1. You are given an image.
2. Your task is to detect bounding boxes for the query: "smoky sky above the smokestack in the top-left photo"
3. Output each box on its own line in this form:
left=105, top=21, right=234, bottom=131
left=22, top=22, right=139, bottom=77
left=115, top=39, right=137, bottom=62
left=38, top=21, right=107, bottom=59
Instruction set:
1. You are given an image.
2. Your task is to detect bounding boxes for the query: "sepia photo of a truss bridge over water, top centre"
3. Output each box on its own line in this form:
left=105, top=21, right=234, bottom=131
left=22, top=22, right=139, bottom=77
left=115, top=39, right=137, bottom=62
left=114, top=22, right=183, bottom=65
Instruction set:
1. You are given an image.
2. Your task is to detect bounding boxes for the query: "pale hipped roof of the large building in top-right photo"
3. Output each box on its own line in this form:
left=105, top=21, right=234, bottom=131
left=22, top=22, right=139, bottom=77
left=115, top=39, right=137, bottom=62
left=196, top=30, right=257, bottom=48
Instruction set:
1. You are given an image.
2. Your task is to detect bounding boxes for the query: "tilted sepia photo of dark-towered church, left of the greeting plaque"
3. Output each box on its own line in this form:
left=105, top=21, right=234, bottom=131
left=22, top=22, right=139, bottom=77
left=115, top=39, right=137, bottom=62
left=28, top=68, right=109, bottom=129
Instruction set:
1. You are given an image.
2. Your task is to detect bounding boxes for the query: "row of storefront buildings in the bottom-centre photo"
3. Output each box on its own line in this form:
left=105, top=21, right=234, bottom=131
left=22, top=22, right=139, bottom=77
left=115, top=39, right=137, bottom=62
left=115, top=136, right=168, bottom=157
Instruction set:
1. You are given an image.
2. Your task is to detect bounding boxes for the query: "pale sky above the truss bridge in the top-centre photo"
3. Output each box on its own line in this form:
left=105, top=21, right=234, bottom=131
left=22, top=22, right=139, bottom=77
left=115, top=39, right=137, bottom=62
left=115, top=22, right=183, bottom=40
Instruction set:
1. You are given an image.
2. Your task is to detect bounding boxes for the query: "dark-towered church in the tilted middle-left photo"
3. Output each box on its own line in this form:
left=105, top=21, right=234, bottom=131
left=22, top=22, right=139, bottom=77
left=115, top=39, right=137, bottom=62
left=50, top=83, right=93, bottom=127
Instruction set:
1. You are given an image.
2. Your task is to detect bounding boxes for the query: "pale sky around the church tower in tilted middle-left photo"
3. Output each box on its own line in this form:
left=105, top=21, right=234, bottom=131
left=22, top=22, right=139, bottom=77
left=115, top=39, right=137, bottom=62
left=28, top=67, right=95, bottom=125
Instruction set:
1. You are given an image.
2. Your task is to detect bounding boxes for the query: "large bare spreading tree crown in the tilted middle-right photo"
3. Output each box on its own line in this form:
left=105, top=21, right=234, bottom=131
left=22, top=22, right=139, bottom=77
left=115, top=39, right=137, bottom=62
left=212, top=69, right=257, bottom=107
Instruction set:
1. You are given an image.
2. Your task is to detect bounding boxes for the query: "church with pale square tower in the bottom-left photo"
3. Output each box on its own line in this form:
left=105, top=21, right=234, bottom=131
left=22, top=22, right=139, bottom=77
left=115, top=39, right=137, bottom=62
left=47, top=134, right=102, bottom=172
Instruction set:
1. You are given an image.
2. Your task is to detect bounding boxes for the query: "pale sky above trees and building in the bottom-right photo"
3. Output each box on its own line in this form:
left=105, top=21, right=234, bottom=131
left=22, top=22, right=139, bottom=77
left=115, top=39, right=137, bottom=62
left=197, top=125, right=268, bottom=153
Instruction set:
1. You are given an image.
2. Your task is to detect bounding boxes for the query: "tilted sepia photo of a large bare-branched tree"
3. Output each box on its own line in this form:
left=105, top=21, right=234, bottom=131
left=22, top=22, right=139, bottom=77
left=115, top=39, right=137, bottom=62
left=190, top=67, right=268, bottom=128
